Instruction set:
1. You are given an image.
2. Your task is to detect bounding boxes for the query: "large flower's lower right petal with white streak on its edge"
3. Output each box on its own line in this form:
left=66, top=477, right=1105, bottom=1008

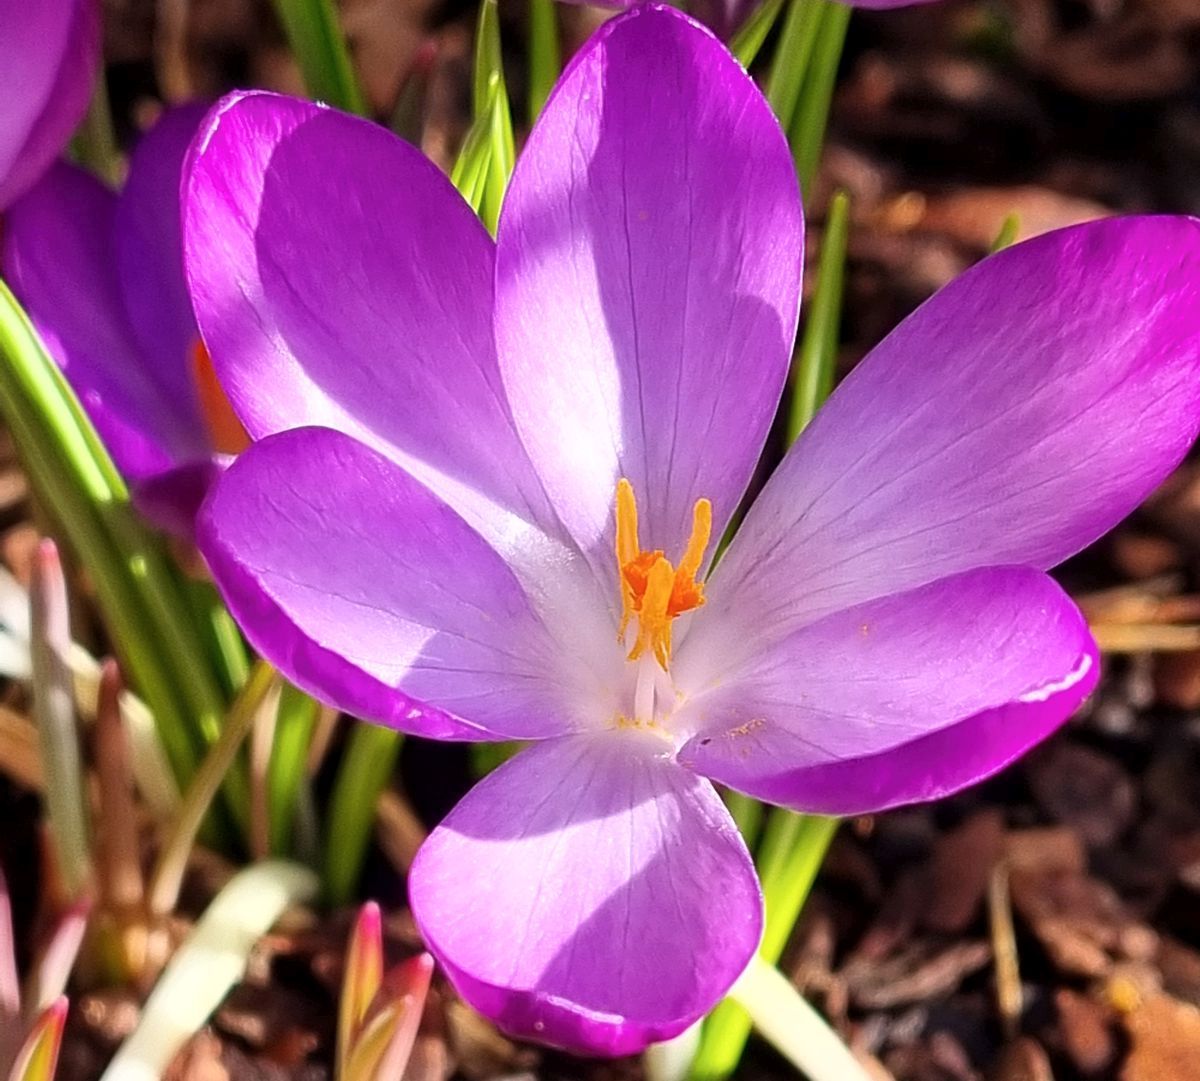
left=679, top=567, right=1099, bottom=815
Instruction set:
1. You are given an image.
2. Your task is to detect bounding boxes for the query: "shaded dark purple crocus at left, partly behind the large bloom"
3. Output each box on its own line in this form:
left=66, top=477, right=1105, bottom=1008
left=0, top=106, right=245, bottom=536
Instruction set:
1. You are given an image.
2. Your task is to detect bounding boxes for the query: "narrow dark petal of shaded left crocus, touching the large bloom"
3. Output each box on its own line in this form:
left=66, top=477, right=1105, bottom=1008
left=114, top=104, right=208, bottom=400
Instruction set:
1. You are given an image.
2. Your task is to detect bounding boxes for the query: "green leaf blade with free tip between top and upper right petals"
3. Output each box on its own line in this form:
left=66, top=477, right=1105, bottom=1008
left=787, top=192, right=850, bottom=444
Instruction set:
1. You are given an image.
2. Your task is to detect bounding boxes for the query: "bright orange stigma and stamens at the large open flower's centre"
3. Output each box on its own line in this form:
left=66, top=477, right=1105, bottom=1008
left=617, top=478, right=713, bottom=669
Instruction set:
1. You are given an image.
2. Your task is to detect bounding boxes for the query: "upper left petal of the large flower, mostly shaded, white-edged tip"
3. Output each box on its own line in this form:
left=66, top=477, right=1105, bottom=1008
left=184, top=92, right=548, bottom=551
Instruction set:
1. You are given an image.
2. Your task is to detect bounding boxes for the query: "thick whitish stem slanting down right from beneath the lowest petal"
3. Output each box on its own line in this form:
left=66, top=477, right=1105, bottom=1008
left=730, top=954, right=872, bottom=1081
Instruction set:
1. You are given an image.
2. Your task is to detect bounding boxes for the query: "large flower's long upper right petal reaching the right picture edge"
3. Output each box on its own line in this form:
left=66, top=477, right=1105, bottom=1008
left=684, top=217, right=1200, bottom=663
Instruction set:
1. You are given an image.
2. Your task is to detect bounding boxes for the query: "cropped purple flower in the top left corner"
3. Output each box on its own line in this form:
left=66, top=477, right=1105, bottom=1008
left=0, top=0, right=100, bottom=211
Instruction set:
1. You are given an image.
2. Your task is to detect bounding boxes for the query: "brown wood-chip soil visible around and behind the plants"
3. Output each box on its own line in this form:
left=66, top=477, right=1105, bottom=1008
left=0, top=0, right=1200, bottom=1081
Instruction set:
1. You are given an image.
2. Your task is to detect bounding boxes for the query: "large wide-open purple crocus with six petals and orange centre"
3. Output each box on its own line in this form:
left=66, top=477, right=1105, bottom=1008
left=184, top=6, right=1200, bottom=1053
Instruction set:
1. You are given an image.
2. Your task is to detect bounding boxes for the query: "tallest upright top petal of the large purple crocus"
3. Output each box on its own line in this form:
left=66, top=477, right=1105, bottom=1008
left=496, top=5, right=803, bottom=569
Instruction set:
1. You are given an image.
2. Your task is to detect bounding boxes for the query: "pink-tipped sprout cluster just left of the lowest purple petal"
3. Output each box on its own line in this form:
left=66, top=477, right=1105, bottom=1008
left=337, top=901, right=433, bottom=1081
